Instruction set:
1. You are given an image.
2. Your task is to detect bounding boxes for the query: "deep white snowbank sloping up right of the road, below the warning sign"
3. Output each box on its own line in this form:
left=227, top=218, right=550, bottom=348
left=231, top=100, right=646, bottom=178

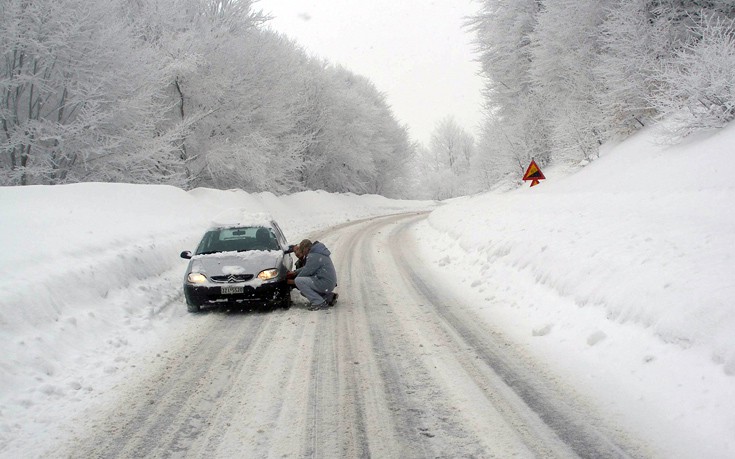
left=419, top=124, right=735, bottom=457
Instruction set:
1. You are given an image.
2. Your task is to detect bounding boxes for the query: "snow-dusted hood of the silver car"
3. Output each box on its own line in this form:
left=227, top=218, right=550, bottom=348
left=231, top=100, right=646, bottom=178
left=189, top=250, right=283, bottom=276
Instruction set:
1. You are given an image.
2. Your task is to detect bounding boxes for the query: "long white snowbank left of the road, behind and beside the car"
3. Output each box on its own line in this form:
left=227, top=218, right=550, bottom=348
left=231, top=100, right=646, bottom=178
left=0, top=187, right=435, bottom=456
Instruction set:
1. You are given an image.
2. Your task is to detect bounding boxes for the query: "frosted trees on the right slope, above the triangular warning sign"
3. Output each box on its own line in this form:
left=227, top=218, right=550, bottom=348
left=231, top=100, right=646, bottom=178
left=468, top=0, right=735, bottom=191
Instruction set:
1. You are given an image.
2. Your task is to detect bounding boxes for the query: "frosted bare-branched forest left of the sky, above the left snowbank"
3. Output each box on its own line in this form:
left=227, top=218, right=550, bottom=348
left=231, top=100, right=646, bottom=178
left=0, top=0, right=415, bottom=196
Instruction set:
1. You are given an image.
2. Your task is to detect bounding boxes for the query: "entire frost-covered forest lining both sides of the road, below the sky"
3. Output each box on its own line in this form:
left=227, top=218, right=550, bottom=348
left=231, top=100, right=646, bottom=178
left=0, top=0, right=735, bottom=199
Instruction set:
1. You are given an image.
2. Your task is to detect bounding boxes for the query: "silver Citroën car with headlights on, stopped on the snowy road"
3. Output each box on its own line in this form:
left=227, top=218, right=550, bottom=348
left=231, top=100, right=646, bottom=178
left=181, top=220, right=293, bottom=313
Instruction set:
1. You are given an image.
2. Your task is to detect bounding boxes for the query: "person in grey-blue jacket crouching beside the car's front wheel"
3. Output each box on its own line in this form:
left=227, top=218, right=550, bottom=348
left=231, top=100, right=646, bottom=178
left=287, top=239, right=338, bottom=311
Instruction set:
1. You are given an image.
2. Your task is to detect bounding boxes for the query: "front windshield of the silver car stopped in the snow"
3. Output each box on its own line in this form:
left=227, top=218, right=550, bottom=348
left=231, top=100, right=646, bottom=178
left=196, top=226, right=279, bottom=255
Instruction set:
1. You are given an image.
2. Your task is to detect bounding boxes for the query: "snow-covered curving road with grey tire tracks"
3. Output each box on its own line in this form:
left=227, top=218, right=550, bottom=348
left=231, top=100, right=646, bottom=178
left=63, top=214, right=649, bottom=458
